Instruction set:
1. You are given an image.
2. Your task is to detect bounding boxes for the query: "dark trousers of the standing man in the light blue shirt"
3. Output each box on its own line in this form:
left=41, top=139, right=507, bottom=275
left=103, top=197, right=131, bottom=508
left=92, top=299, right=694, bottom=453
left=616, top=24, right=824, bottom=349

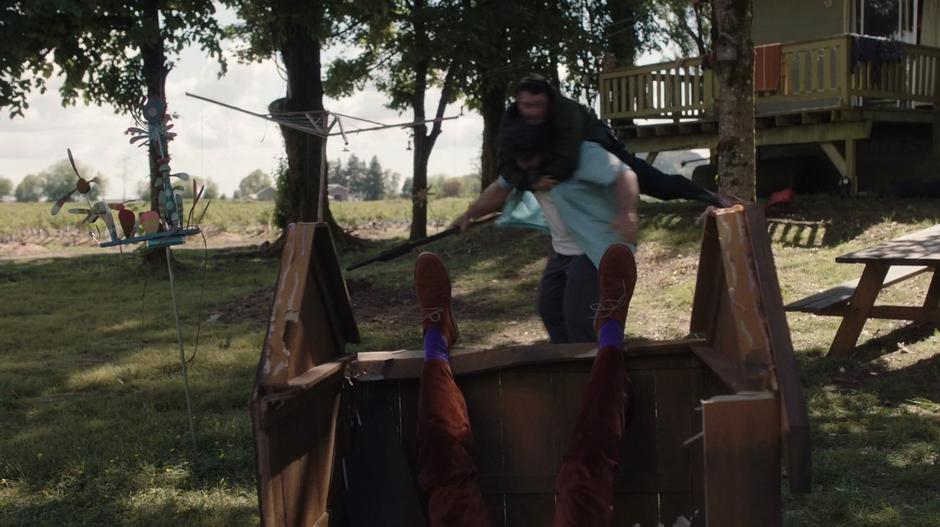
left=536, top=253, right=600, bottom=344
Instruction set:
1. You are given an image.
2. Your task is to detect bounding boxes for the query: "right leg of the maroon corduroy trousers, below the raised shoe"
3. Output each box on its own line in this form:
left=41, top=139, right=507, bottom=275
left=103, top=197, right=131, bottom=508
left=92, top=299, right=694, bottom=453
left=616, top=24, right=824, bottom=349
left=554, top=348, right=628, bottom=527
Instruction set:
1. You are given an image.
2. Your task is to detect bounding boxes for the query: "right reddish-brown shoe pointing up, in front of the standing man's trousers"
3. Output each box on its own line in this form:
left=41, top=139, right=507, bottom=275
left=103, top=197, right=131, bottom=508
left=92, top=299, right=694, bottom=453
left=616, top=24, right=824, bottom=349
left=594, top=243, right=636, bottom=334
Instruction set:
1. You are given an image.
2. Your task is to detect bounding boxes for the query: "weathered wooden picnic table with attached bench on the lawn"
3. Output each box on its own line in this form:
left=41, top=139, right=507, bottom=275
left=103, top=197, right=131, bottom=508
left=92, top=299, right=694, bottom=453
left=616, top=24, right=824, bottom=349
left=786, top=225, right=940, bottom=356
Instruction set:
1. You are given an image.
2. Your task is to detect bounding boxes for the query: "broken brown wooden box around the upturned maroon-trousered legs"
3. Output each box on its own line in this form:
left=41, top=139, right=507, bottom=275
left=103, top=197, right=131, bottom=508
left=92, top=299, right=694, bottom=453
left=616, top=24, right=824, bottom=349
left=251, top=207, right=810, bottom=527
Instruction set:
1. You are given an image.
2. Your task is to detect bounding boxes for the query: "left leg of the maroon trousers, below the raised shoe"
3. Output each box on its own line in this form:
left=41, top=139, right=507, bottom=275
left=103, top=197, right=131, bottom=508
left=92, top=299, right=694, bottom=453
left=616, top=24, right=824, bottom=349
left=418, top=360, right=489, bottom=527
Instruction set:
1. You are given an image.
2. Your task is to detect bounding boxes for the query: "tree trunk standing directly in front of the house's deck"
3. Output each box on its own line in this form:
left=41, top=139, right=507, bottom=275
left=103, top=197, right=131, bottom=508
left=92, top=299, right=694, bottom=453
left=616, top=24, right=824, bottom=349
left=712, top=0, right=756, bottom=202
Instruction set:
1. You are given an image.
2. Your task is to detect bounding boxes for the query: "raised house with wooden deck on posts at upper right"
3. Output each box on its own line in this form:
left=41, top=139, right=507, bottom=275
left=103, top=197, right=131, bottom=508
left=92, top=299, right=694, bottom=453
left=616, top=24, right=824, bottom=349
left=600, top=0, right=940, bottom=195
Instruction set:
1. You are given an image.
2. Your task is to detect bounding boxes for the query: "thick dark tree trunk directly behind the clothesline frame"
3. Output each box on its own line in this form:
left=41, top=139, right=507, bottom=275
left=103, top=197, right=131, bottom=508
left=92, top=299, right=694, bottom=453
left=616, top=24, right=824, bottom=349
left=269, top=14, right=344, bottom=238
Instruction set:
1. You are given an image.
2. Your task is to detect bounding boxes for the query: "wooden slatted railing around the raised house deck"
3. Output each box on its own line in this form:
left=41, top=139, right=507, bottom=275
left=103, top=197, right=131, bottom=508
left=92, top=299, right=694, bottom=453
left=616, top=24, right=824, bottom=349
left=600, top=35, right=940, bottom=120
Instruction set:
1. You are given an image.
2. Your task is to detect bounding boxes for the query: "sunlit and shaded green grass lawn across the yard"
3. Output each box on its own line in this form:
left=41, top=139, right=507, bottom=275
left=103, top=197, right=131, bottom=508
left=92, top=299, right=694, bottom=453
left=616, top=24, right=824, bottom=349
left=0, top=198, right=940, bottom=527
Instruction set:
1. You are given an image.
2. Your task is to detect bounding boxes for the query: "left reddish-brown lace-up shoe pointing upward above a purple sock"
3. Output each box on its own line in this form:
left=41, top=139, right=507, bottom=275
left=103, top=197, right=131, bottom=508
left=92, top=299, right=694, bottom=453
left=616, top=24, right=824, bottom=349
left=415, top=253, right=458, bottom=350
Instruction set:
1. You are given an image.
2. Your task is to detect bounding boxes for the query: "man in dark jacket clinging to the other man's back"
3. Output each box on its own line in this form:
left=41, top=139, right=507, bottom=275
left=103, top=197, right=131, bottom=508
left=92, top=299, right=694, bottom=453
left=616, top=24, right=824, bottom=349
left=497, top=75, right=731, bottom=207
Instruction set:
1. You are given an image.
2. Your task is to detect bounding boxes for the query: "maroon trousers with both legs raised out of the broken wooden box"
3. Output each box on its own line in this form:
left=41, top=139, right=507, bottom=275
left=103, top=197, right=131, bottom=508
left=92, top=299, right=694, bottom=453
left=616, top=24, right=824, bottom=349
left=418, top=348, right=628, bottom=527
